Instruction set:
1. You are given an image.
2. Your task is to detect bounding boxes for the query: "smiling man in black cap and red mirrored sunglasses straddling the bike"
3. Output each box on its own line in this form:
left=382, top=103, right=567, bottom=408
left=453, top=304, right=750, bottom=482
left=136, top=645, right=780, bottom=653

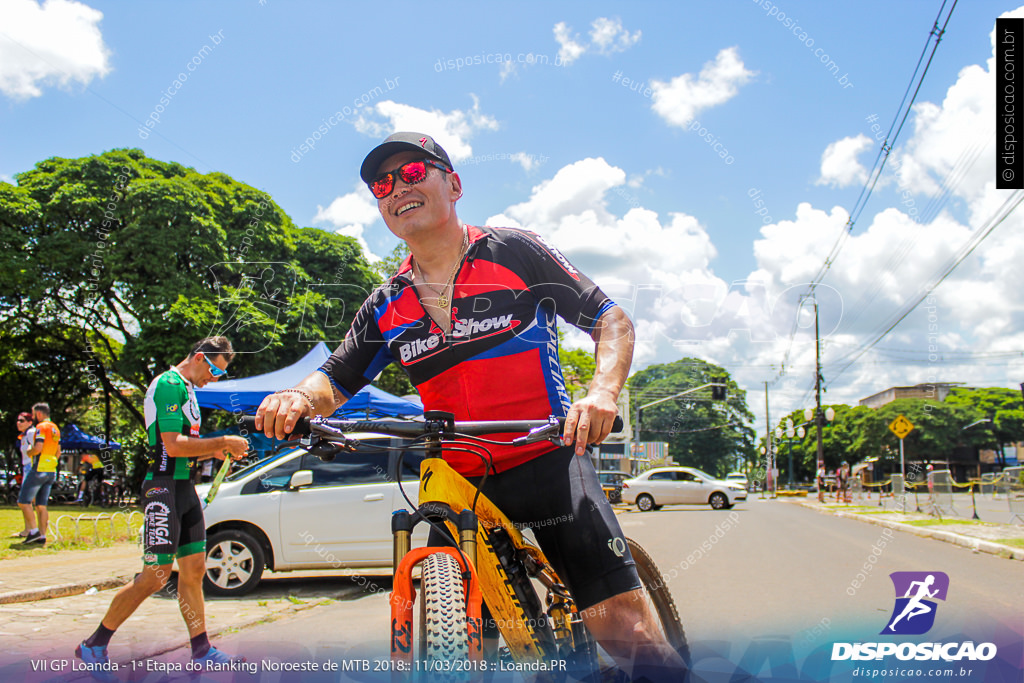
left=256, top=132, right=684, bottom=680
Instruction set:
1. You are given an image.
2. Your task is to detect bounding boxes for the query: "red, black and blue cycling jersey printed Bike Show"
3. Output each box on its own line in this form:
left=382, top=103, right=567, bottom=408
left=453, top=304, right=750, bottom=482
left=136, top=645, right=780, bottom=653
left=321, top=225, right=615, bottom=476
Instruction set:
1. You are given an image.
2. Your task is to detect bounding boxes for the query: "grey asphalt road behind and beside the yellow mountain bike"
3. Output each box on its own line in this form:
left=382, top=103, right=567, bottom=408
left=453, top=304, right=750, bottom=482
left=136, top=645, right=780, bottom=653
left=193, top=499, right=1024, bottom=681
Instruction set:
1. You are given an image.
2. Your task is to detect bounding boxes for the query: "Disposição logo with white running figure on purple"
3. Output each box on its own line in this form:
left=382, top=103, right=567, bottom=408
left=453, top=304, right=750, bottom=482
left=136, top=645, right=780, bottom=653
left=831, top=571, right=996, bottom=661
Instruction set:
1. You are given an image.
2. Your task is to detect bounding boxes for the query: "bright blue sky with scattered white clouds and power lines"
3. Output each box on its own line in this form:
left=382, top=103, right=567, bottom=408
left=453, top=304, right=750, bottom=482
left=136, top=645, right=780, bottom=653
left=0, top=0, right=1024, bottom=438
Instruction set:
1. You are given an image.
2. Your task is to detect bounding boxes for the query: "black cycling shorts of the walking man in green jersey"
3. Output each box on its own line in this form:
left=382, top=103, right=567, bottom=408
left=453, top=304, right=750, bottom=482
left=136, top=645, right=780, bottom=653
left=141, top=477, right=206, bottom=565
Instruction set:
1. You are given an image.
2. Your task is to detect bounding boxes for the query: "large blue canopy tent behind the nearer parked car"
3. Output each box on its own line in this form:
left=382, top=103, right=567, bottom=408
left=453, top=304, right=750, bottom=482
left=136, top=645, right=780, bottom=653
left=196, top=342, right=423, bottom=419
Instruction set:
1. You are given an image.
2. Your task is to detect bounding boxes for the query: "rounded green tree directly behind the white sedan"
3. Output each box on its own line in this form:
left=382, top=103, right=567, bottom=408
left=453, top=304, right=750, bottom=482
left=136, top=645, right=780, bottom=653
left=629, top=358, right=755, bottom=475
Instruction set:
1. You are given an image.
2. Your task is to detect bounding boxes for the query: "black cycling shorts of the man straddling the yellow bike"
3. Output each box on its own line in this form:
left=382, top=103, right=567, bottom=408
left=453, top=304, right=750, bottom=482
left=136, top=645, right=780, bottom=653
left=428, top=446, right=642, bottom=610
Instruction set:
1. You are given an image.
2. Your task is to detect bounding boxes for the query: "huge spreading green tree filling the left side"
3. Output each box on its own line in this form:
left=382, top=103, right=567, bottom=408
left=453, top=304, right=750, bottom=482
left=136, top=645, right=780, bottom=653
left=0, top=150, right=379, bottom=471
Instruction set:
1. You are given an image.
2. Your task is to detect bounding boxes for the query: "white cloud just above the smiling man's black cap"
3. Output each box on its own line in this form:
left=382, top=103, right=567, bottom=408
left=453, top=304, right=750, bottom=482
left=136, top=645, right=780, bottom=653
left=355, top=95, right=499, bottom=164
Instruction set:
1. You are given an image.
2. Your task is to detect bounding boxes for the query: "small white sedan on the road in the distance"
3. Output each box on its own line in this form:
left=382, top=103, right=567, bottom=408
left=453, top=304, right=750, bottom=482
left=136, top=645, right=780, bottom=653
left=623, top=467, right=746, bottom=512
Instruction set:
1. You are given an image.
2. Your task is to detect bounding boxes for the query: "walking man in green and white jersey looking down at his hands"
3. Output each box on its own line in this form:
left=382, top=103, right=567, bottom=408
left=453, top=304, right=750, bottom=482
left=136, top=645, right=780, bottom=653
left=75, top=337, right=249, bottom=671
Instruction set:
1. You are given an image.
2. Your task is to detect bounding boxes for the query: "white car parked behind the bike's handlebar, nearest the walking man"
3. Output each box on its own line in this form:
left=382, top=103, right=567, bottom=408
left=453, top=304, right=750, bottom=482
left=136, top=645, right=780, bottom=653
left=196, top=434, right=427, bottom=596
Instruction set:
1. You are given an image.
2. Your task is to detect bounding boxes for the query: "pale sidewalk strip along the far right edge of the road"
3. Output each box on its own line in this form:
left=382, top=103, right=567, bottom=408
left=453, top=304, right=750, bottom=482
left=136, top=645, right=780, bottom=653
left=777, top=495, right=1024, bottom=560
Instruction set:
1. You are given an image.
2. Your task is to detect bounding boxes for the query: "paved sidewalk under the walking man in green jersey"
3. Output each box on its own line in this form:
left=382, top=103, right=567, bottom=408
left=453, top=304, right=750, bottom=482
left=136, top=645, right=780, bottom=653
left=0, top=544, right=376, bottom=682
